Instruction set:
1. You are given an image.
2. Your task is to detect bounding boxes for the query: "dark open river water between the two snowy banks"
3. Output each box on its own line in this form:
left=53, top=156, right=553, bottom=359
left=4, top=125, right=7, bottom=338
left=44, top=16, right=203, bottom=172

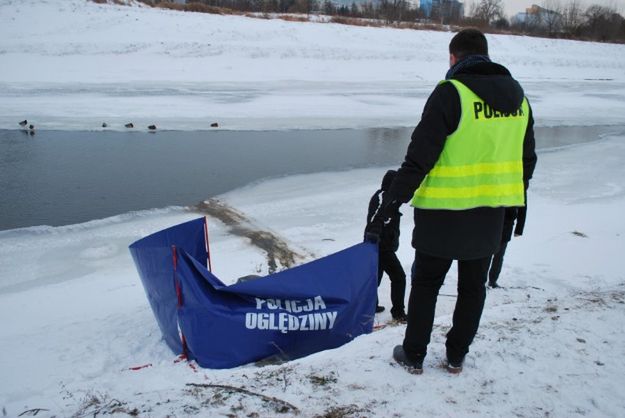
left=0, top=126, right=625, bottom=230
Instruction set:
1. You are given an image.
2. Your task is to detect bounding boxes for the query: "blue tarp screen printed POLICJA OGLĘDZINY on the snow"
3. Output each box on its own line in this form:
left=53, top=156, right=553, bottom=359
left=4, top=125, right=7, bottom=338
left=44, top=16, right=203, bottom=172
left=130, top=218, right=378, bottom=368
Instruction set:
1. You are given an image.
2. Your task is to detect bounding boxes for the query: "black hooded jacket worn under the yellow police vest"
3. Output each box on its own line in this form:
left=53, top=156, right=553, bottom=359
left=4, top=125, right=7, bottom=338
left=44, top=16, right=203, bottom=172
left=388, top=62, right=536, bottom=260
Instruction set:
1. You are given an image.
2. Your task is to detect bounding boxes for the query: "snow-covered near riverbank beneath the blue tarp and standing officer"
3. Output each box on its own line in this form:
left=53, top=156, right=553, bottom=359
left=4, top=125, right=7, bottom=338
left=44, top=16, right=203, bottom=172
left=0, top=137, right=625, bottom=417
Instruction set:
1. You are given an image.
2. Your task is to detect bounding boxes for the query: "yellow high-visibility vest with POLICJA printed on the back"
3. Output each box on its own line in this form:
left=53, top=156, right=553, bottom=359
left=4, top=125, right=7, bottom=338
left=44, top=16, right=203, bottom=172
left=411, top=80, right=529, bottom=210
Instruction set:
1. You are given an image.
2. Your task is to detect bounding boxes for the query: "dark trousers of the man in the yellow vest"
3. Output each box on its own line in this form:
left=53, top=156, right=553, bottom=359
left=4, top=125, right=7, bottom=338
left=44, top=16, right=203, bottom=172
left=403, top=252, right=491, bottom=362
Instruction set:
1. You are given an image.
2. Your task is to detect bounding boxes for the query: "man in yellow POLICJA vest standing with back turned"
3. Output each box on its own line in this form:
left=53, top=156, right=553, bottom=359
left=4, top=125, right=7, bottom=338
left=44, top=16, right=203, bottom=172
left=368, top=29, right=536, bottom=374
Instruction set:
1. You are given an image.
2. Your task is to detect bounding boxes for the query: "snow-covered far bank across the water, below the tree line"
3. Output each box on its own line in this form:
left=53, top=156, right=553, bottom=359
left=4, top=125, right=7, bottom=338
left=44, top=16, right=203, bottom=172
left=0, top=0, right=625, bottom=130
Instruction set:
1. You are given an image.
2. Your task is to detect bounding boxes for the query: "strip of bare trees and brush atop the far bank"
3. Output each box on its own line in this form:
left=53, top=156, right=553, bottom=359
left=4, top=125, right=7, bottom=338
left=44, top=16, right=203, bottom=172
left=142, top=0, right=625, bottom=43
